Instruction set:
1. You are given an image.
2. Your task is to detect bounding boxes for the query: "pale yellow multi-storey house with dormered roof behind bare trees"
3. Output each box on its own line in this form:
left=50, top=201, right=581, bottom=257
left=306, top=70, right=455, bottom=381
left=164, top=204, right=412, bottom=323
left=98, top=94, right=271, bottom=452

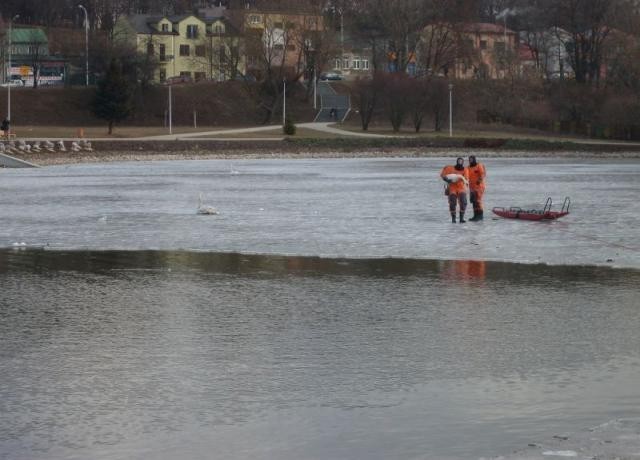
left=115, top=15, right=244, bottom=82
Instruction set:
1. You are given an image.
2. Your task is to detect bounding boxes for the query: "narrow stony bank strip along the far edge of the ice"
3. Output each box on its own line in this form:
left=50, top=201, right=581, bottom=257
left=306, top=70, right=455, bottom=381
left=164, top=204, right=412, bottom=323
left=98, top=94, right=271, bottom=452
left=7, top=138, right=640, bottom=166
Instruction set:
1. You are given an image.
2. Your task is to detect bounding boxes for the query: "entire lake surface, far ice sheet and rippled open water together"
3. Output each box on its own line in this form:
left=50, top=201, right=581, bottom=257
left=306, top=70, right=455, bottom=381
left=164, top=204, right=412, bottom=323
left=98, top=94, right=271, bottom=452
left=0, top=159, right=640, bottom=460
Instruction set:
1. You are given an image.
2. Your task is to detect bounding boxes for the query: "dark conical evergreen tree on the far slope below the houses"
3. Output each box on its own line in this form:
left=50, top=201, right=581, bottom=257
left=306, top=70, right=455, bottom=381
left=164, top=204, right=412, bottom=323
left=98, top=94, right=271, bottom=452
left=93, top=59, right=133, bottom=134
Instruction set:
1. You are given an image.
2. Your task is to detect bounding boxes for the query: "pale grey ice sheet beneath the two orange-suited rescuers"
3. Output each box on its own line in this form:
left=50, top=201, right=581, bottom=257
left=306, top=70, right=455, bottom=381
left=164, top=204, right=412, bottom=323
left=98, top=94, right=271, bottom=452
left=0, top=158, right=640, bottom=268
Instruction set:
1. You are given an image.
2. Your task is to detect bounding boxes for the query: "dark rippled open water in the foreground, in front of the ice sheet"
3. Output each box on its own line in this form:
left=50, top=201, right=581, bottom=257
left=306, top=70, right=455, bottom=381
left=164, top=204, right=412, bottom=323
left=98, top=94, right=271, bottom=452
left=0, top=250, right=640, bottom=459
